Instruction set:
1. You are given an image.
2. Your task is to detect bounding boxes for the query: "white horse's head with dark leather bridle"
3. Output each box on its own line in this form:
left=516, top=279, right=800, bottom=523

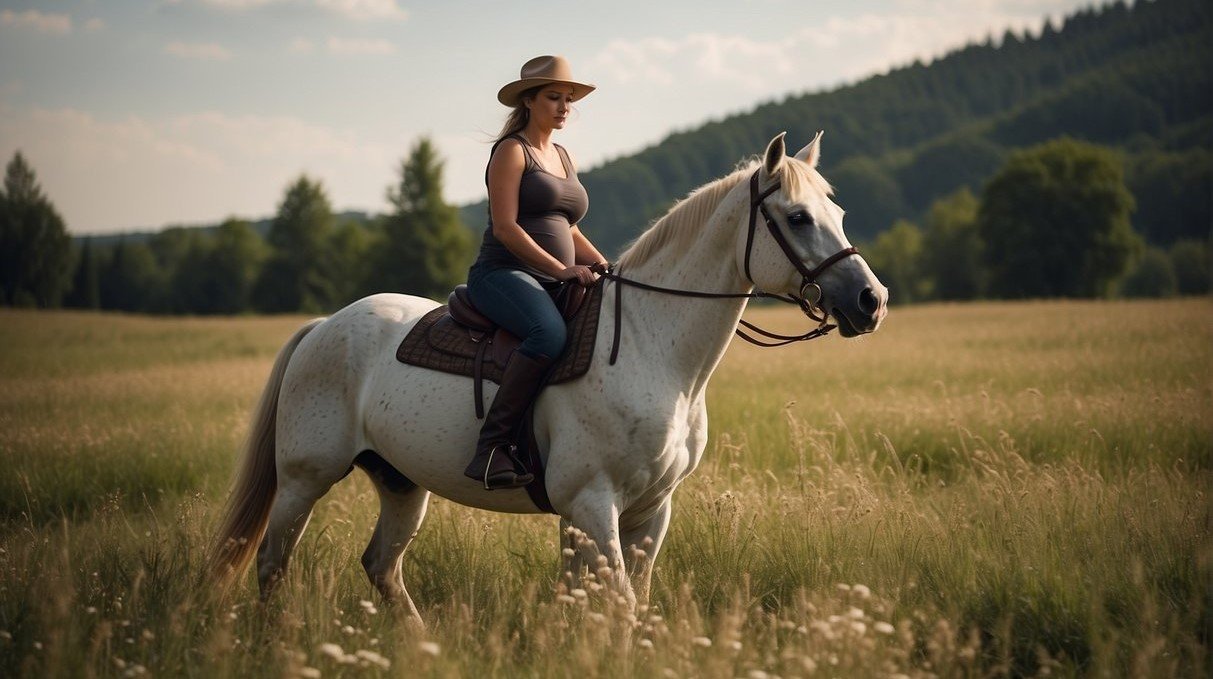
left=738, top=132, right=889, bottom=337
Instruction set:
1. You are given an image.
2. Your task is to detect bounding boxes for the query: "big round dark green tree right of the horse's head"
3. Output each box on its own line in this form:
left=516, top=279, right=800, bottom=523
left=978, top=138, right=1140, bottom=298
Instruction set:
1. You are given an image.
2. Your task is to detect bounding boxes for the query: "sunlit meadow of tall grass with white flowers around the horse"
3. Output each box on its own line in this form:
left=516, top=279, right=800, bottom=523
left=0, top=299, right=1213, bottom=678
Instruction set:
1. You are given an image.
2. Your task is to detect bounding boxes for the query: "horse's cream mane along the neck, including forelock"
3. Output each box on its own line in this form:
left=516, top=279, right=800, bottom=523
left=617, top=158, right=833, bottom=268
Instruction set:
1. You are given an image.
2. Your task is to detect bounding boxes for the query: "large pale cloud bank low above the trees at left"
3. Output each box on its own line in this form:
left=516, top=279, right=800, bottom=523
left=0, top=104, right=397, bottom=233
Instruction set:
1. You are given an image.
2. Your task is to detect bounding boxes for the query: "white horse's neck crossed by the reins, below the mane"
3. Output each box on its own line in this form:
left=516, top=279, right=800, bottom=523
left=621, top=192, right=752, bottom=395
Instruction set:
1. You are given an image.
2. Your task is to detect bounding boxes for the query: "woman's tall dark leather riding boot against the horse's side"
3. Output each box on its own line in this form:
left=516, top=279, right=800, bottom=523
left=463, top=352, right=552, bottom=490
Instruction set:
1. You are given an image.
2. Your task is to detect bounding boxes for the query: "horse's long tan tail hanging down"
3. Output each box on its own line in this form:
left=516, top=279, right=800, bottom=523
left=206, top=319, right=324, bottom=586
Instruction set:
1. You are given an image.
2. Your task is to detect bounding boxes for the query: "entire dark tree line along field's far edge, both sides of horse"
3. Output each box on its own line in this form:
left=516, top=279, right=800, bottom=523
left=0, top=137, right=1213, bottom=314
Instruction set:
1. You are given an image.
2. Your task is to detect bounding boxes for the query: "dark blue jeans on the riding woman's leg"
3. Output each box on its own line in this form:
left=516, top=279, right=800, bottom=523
left=467, top=267, right=568, bottom=359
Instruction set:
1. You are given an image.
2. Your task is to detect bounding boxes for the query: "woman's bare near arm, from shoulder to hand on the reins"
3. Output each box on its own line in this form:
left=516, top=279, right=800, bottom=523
left=489, top=139, right=597, bottom=285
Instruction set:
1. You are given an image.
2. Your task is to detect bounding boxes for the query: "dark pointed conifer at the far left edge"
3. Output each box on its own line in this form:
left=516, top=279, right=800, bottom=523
left=0, top=152, right=72, bottom=308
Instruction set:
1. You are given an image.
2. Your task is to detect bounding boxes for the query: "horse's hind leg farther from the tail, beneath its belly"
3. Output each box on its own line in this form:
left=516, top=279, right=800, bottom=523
left=354, top=451, right=429, bottom=622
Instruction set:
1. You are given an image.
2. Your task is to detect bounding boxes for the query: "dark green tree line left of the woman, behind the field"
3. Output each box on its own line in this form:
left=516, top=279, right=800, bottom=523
left=0, top=138, right=474, bottom=314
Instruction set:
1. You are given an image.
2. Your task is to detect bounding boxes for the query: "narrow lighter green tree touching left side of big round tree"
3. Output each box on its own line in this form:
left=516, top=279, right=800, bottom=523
left=917, top=188, right=985, bottom=301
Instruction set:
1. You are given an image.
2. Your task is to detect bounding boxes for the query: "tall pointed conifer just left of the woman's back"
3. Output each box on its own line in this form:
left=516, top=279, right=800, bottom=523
left=370, top=137, right=474, bottom=298
